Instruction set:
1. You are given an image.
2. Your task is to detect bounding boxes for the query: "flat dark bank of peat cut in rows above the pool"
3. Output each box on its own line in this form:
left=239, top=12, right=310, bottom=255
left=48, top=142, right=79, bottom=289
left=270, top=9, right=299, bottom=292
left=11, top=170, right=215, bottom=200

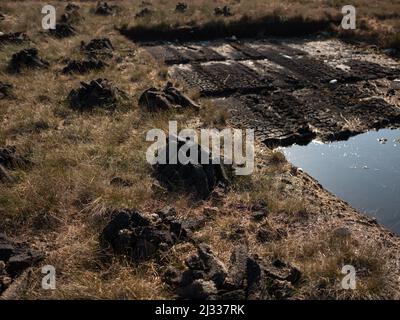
left=143, top=38, right=400, bottom=147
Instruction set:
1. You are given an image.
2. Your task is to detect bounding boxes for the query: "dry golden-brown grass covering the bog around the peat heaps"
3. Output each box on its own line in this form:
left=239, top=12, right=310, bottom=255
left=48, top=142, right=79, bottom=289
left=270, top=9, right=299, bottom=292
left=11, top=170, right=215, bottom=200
left=0, top=0, right=399, bottom=299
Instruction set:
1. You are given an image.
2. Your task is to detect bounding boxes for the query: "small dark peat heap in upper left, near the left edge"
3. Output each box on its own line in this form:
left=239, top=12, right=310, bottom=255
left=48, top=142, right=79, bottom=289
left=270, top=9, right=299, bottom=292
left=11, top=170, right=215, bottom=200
left=8, top=48, right=49, bottom=73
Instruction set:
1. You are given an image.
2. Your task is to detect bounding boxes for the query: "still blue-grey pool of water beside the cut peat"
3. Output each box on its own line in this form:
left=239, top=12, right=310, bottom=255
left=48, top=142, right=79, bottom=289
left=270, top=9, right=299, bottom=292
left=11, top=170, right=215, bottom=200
left=282, top=129, right=400, bottom=234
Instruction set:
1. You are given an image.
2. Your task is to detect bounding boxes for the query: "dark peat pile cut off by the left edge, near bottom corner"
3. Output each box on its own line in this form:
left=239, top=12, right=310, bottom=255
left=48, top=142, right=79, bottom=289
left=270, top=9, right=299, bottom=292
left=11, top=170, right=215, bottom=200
left=0, top=233, right=44, bottom=294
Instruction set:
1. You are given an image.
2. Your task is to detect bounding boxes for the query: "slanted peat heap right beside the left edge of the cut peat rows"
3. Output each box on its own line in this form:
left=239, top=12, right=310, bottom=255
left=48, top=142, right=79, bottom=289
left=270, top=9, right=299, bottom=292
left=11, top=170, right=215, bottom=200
left=139, top=83, right=199, bottom=112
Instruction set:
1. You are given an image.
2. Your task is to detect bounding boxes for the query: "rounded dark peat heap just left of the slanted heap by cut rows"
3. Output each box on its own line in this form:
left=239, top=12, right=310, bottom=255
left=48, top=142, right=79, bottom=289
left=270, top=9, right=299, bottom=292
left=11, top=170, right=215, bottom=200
left=68, top=79, right=127, bottom=111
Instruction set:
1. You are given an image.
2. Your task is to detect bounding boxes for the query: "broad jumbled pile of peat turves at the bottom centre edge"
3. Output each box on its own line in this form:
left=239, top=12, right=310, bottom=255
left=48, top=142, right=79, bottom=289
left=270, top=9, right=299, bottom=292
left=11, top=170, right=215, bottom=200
left=164, top=244, right=301, bottom=300
